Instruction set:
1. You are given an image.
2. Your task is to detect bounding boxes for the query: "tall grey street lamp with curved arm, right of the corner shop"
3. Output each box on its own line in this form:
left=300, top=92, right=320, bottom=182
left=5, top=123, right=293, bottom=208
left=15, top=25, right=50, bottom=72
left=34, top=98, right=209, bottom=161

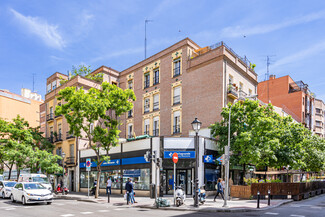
left=223, top=95, right=257, bottom=207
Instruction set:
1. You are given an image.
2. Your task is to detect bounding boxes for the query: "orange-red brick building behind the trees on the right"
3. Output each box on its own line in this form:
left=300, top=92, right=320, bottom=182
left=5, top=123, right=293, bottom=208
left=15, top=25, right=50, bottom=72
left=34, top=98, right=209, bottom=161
left=257, top=75, right=314, bottom=130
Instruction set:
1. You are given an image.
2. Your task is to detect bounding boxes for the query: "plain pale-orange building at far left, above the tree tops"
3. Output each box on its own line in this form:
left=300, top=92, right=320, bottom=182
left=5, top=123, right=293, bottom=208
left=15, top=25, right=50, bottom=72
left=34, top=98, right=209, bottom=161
left=0, top=89, right=43, bottom=127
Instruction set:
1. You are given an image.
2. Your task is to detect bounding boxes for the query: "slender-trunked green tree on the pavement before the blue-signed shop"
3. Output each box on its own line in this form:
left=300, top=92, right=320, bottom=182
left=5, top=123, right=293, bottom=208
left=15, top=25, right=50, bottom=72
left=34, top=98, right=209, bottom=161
left=55, top=82, right=136, bottom=198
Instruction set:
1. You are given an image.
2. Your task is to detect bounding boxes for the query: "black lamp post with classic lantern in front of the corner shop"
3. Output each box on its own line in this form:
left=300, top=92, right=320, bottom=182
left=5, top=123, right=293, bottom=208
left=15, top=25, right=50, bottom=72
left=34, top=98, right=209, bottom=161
left=191, top=118, right=202, bottom=207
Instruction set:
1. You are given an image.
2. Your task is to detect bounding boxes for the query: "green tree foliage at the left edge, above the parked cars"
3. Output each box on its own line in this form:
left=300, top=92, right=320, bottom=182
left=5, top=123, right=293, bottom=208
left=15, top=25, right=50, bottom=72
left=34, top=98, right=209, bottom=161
left=0, top=115, right=61, bottom=179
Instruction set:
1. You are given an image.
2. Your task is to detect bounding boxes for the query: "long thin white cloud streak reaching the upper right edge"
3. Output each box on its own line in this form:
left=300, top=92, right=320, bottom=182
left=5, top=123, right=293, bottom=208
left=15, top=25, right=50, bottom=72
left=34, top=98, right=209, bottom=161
left=221, top=11, right=325, bottom=38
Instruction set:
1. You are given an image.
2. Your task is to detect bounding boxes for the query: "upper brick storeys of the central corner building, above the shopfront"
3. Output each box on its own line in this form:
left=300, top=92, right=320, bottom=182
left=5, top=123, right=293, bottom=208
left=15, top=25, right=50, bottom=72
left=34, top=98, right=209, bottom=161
left=120, top=38, right=257, bottom=138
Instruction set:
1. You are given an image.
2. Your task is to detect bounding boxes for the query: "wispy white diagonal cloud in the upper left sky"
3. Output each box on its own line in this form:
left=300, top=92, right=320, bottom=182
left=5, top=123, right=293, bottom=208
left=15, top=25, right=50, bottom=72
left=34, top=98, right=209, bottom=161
left=10, top=9, right=66, bottom=49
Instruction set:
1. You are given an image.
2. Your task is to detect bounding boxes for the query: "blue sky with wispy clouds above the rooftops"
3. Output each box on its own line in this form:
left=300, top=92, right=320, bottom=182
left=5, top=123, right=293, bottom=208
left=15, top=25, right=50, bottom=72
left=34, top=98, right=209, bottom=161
left=0, top=0, right=325, bottom=100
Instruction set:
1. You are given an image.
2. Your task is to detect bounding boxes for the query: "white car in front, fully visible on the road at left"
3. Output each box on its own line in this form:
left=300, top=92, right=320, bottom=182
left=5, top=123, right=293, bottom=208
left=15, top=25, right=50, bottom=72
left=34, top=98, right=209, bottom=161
left=10, top=182, right=53, bottom=205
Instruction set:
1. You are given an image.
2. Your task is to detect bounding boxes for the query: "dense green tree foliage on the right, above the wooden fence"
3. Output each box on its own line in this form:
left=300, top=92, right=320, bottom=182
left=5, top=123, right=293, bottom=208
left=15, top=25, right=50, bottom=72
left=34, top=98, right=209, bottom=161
left=210, top=100, right=325, bottom=175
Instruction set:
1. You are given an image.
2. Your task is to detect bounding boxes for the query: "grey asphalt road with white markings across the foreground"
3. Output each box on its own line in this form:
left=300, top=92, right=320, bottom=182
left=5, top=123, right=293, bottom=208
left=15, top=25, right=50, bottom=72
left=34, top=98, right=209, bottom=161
left=0, top=195, right=325, bottom=217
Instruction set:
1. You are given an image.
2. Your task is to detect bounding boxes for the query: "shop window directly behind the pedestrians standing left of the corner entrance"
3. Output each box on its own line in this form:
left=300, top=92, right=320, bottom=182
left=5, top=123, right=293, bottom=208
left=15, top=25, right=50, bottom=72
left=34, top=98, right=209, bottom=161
left=123, top=169, right=150, bottom=190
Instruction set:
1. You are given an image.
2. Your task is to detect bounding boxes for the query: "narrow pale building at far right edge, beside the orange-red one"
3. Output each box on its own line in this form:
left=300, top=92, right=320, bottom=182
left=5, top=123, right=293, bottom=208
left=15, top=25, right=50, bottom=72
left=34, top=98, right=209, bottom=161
left=314, top=99, right=325, bottom=138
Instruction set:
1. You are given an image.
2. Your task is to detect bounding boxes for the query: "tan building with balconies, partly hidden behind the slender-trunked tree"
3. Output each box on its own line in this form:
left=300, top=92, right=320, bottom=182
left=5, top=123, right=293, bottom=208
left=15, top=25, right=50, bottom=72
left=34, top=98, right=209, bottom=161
left=40, top=66, right=119, bottom=191
